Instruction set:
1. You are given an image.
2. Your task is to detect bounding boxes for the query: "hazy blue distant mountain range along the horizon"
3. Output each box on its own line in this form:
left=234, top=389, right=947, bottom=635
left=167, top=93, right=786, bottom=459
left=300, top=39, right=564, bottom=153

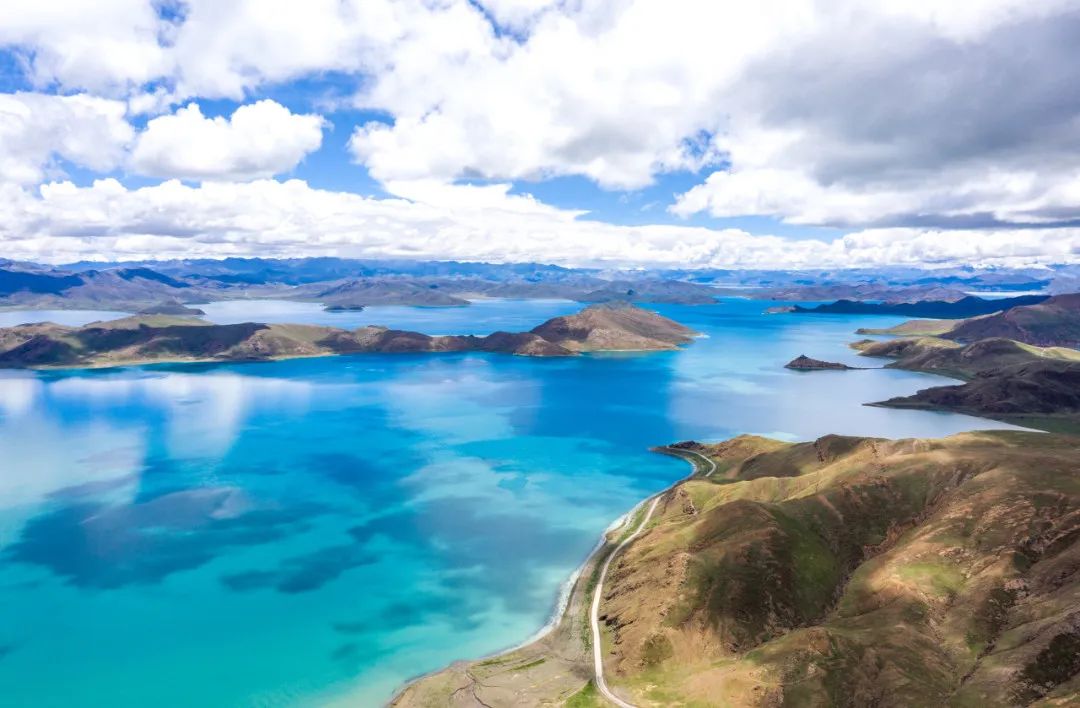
left=0, top=258, right=1080, bottom=316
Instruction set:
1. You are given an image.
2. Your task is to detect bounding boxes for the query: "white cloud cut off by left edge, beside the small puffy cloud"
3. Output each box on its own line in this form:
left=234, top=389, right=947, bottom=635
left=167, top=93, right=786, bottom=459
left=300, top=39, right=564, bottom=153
left=0, top=93, right=134, bottom=183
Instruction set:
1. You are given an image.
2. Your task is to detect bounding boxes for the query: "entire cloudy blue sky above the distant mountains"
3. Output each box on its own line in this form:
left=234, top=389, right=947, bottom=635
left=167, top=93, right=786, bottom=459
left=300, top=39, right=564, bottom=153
left=0, top=0, right=1080, bottom=269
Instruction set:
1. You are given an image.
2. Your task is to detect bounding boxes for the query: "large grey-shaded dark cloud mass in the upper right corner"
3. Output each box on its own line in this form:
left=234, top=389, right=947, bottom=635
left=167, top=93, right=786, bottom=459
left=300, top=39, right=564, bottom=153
left=673, top=0, right=1080, bottom=226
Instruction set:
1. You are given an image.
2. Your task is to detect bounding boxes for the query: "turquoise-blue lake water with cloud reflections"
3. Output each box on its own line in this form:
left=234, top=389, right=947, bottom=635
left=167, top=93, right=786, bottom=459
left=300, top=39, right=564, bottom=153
left=0, top=299, right=1019, bottom=707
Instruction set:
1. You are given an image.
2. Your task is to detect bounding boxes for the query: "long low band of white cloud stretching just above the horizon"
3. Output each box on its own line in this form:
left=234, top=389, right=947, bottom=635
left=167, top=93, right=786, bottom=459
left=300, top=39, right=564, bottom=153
left=0, top=179, right=1080, bottom=268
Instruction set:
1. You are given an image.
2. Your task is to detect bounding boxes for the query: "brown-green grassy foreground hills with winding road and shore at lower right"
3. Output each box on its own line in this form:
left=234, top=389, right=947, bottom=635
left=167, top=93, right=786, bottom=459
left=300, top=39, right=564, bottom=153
left=392, top=431, right=1080, bottom=708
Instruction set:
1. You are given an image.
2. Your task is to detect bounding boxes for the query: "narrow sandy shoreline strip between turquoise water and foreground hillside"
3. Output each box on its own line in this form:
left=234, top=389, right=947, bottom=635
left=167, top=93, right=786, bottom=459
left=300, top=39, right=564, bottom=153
left=383, top=446, right=715, bottom=708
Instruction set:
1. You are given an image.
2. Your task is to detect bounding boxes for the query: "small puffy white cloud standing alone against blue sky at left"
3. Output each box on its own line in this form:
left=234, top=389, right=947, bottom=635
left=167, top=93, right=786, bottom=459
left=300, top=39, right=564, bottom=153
left=132, top=99, right=324, bottom=179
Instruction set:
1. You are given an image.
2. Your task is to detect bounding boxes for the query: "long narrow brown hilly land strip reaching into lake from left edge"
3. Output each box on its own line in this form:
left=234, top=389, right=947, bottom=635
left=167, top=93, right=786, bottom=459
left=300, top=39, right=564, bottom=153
left=0, top=303, right=698, bottom=368
